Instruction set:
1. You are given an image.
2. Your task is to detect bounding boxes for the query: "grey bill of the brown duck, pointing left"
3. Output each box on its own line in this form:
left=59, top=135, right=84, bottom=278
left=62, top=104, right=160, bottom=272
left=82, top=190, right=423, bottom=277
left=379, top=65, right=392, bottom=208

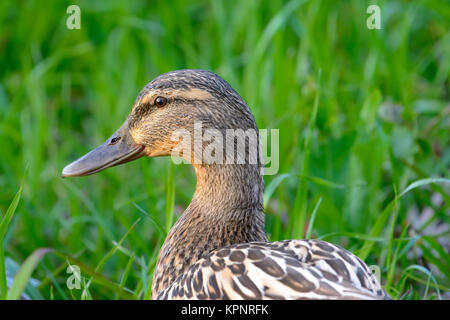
left=61, top=122, right=145, bottom=178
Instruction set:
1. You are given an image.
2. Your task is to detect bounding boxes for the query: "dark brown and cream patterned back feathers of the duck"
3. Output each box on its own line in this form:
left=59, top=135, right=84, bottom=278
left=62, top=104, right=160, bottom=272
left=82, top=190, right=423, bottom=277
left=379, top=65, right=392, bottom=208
left=156, top=240, right=390, bottom=300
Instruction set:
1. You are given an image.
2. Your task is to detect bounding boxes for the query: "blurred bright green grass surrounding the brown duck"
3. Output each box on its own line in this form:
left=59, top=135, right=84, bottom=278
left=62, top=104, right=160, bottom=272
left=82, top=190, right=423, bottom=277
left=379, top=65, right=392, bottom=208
left=0, top=0, right=450, bottom=299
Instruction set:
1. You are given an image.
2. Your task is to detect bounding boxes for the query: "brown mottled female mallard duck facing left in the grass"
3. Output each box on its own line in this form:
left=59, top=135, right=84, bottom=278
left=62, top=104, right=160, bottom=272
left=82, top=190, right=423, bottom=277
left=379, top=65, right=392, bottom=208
left=62, top=70, right=390, bottom=299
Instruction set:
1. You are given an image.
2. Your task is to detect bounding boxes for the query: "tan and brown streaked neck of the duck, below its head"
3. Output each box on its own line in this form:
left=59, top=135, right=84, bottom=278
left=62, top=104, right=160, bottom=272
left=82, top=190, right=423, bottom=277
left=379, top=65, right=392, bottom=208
left=152, top=164, right=267, bottom=297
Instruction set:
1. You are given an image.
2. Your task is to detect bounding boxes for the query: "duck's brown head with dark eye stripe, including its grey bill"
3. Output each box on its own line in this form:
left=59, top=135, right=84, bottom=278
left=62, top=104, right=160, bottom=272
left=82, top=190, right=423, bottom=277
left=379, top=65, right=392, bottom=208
left=62, top=70, right=257, bottom=177
